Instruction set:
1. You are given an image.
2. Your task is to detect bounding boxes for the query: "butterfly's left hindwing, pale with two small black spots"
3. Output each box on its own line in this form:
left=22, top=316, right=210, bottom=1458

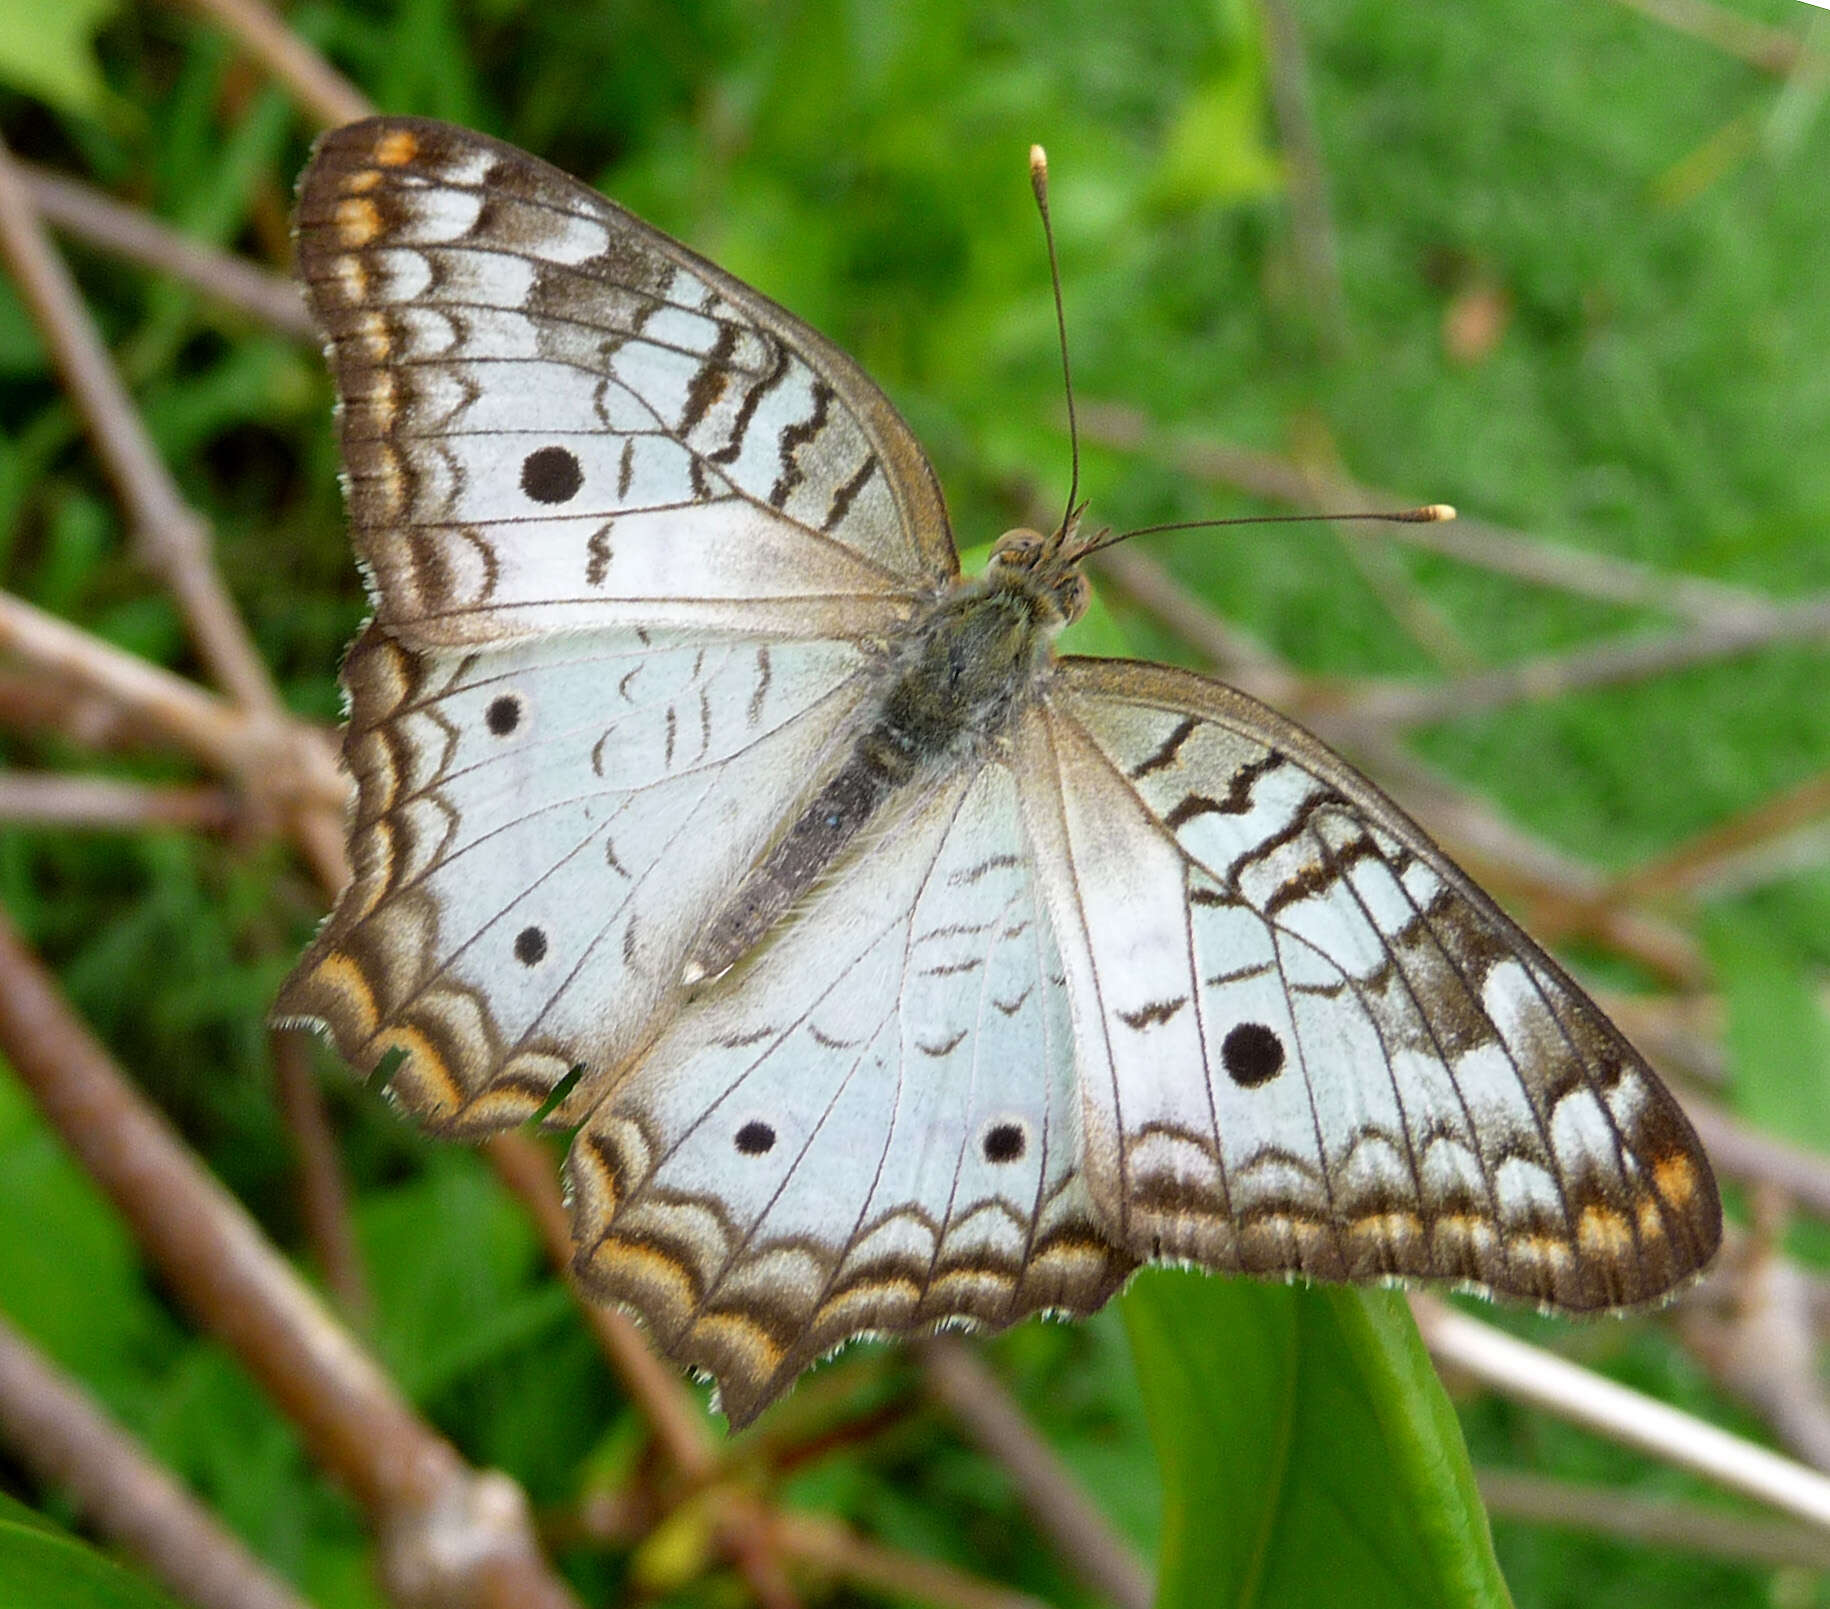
left=276, top=626, right=866, bottom=1133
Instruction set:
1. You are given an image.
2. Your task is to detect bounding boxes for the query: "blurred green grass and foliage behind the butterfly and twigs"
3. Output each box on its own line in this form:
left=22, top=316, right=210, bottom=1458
left=0, top=0, right=1830, bottom=1609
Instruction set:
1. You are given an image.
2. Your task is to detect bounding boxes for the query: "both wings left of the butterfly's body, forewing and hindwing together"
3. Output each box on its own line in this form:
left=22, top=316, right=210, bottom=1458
left=276, top=119, right=957, bottom=1133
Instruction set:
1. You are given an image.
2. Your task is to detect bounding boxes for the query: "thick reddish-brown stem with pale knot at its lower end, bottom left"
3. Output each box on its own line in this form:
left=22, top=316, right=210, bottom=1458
left=0, top=919, right=573, bottom=1609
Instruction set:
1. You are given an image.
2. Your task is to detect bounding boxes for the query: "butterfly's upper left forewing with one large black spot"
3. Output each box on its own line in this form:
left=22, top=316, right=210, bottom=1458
left=296, top=117, right=957, bottom=648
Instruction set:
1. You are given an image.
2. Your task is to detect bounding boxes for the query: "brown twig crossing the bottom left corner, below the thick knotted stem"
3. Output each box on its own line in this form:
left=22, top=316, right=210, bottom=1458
left=0, top=1318, right=307, bottom=1609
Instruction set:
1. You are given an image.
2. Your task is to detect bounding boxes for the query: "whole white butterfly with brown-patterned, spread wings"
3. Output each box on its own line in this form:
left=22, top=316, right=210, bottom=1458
left=276, top=117, right=1720, bottom=1426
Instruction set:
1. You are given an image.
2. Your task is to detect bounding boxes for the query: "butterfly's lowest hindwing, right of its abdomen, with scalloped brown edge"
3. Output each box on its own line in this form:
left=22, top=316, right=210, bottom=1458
left=569, top=763, right=1133, bottom=1426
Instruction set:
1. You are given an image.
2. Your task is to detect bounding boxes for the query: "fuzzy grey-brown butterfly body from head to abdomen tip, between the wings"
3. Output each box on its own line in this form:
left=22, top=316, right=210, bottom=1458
left=684, top=531, right=1085, bottom=983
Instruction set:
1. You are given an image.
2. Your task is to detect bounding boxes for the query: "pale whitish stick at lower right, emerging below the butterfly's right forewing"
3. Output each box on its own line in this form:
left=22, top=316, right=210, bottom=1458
left=1411, top=1292, right=1830, bottom=1532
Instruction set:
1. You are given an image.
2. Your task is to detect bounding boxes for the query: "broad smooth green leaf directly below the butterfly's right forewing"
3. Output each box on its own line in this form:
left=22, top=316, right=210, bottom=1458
left=1125, top=1270, right=1512, bottom=1609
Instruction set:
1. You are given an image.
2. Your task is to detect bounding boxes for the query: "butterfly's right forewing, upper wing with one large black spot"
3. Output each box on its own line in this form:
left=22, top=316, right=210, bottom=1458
left=1017, top=659, right=1720, bottom=1309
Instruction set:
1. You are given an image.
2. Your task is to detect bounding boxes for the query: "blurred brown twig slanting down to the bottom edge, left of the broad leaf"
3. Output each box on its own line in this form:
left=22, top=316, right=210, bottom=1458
left=915, top=1334, right=1155, bottom=1609
